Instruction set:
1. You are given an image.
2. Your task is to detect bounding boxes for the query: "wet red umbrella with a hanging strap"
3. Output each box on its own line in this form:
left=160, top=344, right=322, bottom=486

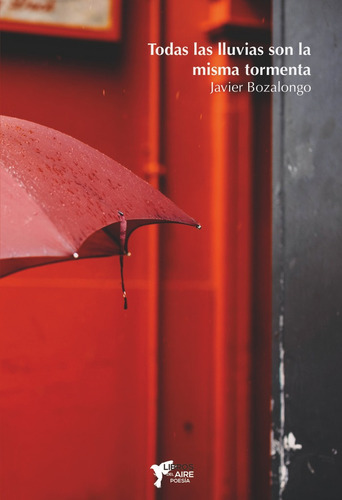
left=0, top=116, right=200, bottom=305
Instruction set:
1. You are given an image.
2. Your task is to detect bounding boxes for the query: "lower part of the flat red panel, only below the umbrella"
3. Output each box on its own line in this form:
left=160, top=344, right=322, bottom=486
left=0, top=276, right=152, bottom=500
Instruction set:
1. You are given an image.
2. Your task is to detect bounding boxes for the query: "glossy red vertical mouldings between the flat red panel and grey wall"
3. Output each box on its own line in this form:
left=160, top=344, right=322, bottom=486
left=159, top=1, right=270, bottom=500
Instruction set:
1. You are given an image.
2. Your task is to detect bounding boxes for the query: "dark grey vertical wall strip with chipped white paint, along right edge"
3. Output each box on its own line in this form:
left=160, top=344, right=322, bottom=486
left=273, top=0, right=342, bottom=500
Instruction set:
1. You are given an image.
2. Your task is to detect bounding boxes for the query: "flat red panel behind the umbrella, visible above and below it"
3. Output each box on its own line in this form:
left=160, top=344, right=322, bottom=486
left=0, top=2, right=156, bottom=500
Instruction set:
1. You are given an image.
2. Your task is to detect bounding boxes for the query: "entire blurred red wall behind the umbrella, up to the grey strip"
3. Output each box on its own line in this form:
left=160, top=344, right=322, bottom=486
left=0, top=0, right=271, bottom=500
